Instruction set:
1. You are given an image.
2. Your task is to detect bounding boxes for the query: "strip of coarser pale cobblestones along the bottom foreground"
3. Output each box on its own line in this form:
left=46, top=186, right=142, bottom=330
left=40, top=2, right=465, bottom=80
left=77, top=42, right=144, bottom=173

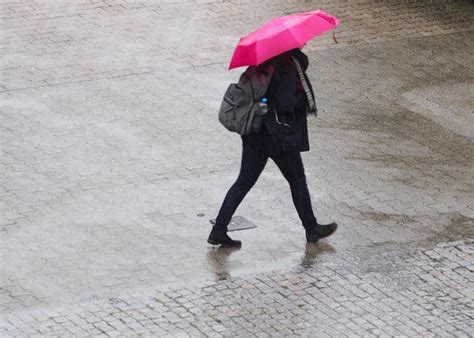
left=0, top=241, right=474, bottom=337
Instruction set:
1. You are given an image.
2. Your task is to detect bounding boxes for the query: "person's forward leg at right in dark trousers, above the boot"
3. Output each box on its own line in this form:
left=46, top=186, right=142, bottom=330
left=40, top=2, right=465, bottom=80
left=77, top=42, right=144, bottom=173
left=272, top=150, right=317, bottom=229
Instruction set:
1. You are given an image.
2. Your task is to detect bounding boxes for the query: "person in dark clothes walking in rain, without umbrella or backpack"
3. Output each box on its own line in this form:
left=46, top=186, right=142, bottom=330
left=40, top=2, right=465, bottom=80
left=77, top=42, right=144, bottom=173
left=207, top=48, right=337, bottom=246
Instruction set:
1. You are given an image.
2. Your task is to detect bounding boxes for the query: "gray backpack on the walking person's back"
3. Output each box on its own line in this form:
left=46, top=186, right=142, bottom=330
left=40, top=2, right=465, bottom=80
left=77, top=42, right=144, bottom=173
left=219, top=65, right=273, bottom=135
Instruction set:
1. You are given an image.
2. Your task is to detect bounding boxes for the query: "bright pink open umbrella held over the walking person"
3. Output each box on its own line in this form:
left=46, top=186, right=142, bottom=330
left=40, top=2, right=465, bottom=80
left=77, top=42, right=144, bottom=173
left=229, top=10, right=339, bottom=69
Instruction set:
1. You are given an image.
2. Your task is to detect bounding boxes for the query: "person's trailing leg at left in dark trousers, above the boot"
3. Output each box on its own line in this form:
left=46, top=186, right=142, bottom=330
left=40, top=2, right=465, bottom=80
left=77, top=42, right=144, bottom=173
left=216, top=137, right=268, bottom=231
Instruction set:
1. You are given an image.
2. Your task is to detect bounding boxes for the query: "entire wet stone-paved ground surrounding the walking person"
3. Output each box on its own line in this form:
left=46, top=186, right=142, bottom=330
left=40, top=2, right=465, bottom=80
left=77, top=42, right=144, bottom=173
left=0, top=0, right=474, bottom=336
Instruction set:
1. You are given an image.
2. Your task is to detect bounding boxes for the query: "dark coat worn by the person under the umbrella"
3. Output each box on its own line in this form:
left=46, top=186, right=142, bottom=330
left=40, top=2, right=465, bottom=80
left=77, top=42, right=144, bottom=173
left=262, top=49, right=314, bottom=151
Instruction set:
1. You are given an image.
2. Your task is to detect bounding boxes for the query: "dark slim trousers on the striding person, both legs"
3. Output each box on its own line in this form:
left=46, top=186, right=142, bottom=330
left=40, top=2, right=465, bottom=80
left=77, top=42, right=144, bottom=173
left=216, top=134, right=316, bottom=230
